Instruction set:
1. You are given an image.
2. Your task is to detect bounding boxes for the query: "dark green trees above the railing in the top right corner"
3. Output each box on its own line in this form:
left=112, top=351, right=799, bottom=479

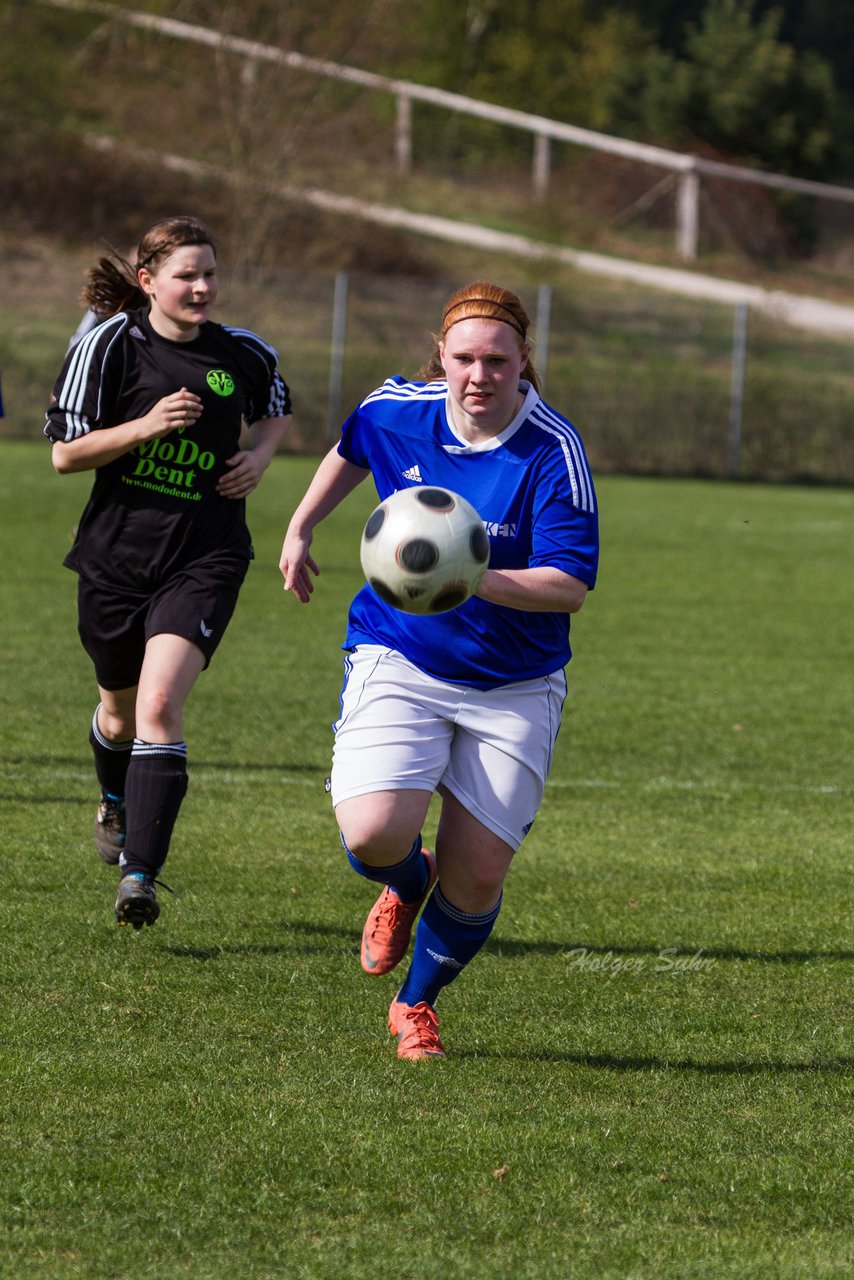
left=387, top=0, right=854, bottom=180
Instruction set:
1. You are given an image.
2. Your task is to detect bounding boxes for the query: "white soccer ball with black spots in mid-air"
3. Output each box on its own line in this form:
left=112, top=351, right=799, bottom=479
left=360, top=485, right=489, bottom=613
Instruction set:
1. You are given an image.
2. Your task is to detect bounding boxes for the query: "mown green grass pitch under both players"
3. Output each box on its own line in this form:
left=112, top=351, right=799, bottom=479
left=0, top=443, right=854, bottom=1280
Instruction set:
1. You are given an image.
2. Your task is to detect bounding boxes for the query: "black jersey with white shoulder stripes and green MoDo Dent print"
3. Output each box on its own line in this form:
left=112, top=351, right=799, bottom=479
left=45, top=308, right=291, bottom=594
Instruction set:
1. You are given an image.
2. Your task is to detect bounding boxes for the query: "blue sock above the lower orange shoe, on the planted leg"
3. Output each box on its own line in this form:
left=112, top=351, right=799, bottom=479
left=397, top=884, right=501, bottom=1005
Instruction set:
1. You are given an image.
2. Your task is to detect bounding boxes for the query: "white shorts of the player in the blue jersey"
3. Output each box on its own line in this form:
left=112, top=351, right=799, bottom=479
left=332, top=645, right=566, bottom=850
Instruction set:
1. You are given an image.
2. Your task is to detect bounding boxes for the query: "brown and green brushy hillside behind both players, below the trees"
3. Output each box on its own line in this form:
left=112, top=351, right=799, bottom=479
left=0, top=3, right=854, bottom=483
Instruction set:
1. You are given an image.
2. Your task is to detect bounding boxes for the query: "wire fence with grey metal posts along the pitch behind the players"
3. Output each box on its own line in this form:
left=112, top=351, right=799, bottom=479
left=0, top=259, right=854, bottom=485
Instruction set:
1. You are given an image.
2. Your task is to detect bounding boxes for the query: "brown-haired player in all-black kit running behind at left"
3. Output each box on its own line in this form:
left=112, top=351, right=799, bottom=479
left=45, top=218, right=291, bottom=928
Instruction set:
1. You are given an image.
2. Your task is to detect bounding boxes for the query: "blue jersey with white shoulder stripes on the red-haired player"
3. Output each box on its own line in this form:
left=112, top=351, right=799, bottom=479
left=338, top=378, right=599, bottom=689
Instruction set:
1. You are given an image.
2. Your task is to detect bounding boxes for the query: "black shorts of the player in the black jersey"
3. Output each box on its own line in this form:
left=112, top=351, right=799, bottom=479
left=77, top=559, right=248, bottom=690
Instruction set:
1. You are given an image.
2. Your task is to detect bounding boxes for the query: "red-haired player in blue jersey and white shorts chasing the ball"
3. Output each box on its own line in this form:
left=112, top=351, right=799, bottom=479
left=279, top=282, right=598, bottom=1060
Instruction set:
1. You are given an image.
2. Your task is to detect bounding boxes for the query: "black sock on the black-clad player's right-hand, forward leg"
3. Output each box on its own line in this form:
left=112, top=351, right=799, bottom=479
left=120, top=739, right=187, bottom=877
